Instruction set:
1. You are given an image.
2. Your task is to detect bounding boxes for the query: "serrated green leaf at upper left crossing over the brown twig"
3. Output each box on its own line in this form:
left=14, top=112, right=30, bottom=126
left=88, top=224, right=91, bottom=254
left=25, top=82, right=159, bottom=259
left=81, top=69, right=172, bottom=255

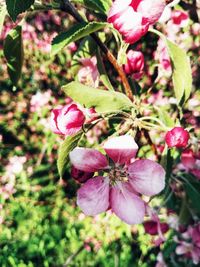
left=52, top=22, right=107, bottom=55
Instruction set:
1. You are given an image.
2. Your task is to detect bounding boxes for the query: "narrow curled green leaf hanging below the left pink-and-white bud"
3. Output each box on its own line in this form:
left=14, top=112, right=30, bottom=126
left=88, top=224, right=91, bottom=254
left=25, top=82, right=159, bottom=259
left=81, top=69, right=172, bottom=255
left=57, top=131, right=83, bottom=177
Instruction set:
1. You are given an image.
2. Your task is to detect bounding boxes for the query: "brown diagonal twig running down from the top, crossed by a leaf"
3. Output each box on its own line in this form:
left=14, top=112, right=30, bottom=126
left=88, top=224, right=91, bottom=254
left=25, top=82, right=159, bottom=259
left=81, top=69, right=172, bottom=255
left=61, top=0, right=134, bottom=102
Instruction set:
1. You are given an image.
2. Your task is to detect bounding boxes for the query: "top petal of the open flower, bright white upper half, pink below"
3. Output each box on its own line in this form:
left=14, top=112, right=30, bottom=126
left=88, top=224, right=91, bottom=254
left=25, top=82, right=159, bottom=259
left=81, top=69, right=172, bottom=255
left=103, top=135, right=138, bottom=164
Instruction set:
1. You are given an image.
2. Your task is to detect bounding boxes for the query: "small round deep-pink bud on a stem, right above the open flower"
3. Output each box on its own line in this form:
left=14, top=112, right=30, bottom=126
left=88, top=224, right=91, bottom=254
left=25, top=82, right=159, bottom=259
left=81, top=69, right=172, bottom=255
left=165, top=127, right=190, bottom=148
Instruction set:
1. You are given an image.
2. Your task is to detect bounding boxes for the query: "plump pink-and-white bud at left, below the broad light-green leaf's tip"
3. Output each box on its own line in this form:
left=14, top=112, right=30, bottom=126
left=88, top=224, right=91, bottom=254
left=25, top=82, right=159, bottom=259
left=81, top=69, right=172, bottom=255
left=50, top=104, right=85, bottom=135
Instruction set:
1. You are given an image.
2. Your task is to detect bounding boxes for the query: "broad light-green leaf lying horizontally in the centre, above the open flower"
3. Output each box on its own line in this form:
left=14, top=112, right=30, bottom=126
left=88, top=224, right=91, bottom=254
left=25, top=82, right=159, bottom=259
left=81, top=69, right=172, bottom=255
left=62, top=82, right=133, bottom=113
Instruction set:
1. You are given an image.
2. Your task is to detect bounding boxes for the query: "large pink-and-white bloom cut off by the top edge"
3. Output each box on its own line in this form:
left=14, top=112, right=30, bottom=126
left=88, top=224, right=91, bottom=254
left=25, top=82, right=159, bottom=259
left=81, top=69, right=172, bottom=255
left=108, top=0, right=166, bottom=44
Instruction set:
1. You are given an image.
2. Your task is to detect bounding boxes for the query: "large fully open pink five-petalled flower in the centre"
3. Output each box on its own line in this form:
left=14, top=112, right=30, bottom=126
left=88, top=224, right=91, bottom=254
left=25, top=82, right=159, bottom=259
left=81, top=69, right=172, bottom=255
left=70, top=135, right=165, bottom=224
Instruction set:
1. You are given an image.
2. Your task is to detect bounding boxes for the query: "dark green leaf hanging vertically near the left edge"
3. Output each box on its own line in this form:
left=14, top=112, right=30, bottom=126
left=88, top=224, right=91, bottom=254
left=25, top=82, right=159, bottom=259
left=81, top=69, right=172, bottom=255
left=4, top=25, right=24, bottom=85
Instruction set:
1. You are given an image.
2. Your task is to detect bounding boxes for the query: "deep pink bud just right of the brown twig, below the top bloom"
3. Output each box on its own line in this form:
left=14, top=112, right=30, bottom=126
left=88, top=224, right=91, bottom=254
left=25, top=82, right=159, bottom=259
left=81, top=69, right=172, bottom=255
left=124, top=50, right=144, bottom=79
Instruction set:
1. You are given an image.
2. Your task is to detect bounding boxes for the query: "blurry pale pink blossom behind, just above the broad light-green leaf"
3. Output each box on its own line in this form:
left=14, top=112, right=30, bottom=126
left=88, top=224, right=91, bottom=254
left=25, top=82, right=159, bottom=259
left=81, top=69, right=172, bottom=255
left=78, top=57, right=99, bottom=87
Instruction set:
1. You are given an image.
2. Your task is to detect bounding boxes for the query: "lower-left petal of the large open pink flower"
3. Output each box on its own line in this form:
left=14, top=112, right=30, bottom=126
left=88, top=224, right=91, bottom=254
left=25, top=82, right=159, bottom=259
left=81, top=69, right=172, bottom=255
left=77, top=176, right=109, bottom=216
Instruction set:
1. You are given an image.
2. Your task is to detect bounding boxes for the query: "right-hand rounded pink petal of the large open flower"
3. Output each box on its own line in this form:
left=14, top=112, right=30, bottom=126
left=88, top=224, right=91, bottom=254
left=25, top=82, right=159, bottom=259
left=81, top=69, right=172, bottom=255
left=128, top=159, right=165, bottom=196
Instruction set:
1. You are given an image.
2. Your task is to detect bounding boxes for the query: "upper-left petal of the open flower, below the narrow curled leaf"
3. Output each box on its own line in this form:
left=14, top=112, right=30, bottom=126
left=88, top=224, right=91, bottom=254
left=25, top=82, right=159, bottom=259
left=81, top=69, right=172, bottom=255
left=69, top=147, right=108, bottom=172
